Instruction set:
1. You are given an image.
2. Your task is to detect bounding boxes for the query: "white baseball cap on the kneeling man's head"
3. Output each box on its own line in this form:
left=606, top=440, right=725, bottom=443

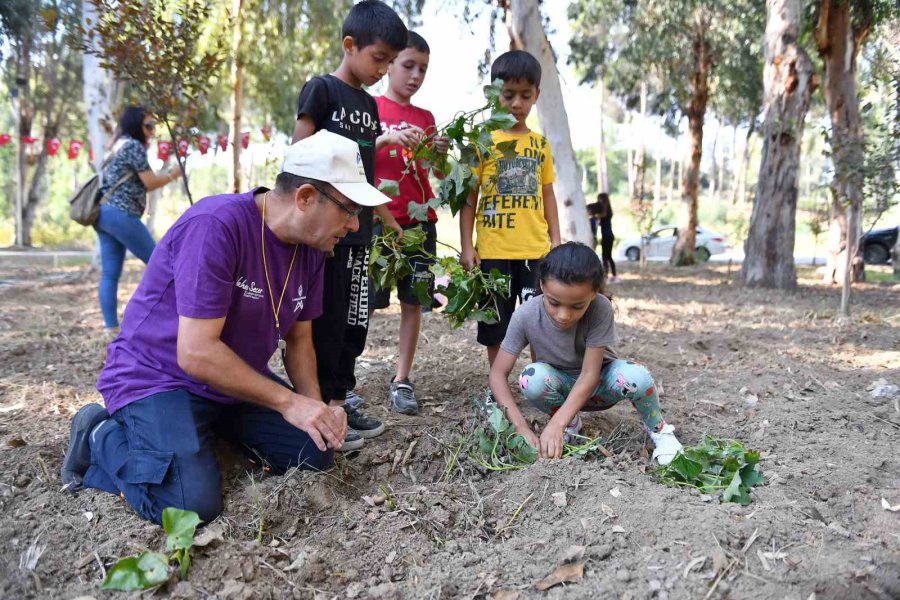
left=281, top=129, right=391, bottom=206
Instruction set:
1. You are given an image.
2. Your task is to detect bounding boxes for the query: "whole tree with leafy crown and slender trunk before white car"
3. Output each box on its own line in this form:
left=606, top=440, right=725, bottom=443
left=569, top=0, right=764, bottom=264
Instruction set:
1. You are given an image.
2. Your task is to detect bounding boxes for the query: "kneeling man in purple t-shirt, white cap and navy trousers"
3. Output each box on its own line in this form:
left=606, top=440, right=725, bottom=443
left=62, top=131, right=390, bottom=523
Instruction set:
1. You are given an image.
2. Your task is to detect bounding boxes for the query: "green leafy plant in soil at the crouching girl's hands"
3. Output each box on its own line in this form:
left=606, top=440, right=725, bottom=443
left=469, top=400, right=603, bottom=471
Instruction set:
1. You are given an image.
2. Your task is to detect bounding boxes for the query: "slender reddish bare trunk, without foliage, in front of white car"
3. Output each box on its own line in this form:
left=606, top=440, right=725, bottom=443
left=670, top=7, right=712, bottom=265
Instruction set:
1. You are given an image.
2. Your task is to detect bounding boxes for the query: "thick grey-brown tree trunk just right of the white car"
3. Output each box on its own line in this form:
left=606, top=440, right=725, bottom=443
left=741, top=0, right=815, bottom=290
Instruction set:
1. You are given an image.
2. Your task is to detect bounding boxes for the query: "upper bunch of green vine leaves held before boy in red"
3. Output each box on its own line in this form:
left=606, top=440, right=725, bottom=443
left=378, top=80, right=516, bottom=221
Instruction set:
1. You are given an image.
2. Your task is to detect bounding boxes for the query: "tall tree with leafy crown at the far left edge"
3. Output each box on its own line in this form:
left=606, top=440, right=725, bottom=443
left=0, top=0, right=81, bottom=246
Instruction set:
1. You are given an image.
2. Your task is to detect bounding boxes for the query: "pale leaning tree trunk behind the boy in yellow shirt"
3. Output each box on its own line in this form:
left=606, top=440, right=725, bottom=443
left=506, top=0, right=593, bottom=246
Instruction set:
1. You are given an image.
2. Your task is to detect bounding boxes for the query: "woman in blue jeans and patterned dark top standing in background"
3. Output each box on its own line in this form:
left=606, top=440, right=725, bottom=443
left=94, top=106, right=181, bottom=335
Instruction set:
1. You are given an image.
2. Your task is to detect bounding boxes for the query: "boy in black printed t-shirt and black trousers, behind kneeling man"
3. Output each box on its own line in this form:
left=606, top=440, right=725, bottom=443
left=293, top=0, right=412, bottom=452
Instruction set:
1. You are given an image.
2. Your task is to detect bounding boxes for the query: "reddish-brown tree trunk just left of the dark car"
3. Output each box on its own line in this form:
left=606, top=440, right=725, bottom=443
left=815, top=0, right=871, bottom=316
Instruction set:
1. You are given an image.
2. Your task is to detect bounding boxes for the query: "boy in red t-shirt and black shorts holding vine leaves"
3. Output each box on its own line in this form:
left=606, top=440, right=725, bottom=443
left=372, top=31, right=449, bottom=414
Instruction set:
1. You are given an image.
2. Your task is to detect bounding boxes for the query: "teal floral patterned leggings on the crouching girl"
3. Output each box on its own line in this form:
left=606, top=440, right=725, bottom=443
left=519, top=360, right=666, bottom=432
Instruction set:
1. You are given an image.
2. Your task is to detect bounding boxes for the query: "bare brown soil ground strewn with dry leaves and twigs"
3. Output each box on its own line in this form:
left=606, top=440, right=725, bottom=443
left=0, top=266, right=900, bottom=600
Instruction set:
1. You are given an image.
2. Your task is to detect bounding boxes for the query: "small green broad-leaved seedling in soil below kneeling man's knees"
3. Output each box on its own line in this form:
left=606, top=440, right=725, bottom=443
left=101, top=507, right=200, bottom=592
